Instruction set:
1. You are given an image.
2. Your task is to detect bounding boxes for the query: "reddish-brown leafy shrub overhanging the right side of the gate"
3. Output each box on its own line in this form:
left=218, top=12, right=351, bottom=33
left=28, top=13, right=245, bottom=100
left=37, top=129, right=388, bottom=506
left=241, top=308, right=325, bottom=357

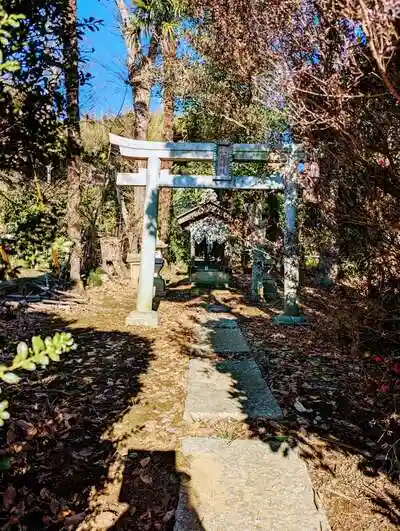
left=191, top=0, right=400, bottom=358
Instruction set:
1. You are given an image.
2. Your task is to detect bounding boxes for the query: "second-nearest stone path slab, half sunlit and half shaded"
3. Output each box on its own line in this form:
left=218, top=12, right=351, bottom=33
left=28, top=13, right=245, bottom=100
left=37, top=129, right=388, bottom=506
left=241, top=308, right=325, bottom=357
left=184, top=360, right=282, bottom=422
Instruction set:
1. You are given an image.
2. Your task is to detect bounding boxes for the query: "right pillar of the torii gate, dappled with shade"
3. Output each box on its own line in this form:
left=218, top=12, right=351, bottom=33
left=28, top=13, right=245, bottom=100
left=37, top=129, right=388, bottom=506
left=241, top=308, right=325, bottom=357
left=275, top=149, right=304, bottom=324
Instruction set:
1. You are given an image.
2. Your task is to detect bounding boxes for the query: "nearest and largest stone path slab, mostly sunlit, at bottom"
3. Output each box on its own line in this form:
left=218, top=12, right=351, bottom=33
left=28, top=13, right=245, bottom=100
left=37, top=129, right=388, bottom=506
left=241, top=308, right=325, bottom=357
left=174, top=437, right=329, bottom=531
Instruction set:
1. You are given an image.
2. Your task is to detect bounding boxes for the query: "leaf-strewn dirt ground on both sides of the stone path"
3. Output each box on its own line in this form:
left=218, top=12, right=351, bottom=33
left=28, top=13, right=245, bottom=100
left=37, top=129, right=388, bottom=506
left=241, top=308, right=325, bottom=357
left=0, top=281, right=400, bottom=531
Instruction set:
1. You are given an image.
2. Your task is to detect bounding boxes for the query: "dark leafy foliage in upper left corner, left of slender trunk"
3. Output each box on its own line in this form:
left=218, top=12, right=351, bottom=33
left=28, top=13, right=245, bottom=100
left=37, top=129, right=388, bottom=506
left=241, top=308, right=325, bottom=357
left=0, top=0, right=65, bottom=175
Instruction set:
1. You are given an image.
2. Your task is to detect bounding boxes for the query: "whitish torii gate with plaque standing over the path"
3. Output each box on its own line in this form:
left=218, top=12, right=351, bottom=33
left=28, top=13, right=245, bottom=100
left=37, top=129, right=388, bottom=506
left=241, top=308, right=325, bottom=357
left=110, top=134, right=304, bottom=327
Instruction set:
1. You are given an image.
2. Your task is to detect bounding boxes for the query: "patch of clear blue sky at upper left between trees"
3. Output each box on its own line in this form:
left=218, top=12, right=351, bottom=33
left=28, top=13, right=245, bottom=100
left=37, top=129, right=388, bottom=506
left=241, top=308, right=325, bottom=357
left=78, top=0, right=159, bottom=117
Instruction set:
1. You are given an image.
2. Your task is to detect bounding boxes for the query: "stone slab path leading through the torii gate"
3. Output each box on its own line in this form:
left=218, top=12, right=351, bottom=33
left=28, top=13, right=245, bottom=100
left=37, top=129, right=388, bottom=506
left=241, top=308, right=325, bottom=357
left=174, top=304, right=329, bottom=531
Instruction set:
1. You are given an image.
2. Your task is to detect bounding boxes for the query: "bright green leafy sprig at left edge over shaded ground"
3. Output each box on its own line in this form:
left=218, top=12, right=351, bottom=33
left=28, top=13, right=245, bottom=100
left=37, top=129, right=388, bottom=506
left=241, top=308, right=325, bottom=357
left=0, top=332, right=77, bottom=426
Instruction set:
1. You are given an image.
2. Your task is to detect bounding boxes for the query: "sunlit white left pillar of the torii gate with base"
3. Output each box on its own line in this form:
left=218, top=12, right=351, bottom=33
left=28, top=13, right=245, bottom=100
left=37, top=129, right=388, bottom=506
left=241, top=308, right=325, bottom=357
left=126, top=156, right=161, bottom=326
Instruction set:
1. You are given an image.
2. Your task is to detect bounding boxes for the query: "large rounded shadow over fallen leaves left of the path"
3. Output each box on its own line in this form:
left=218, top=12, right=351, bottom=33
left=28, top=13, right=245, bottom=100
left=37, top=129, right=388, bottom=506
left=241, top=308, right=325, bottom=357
left=0, top=313, right=153, bottom=530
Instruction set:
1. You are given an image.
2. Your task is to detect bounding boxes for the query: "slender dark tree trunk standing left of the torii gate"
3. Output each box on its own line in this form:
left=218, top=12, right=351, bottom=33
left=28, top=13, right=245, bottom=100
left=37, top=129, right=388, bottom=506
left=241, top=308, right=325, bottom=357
left=63, top=0, right=83, bottom=290
